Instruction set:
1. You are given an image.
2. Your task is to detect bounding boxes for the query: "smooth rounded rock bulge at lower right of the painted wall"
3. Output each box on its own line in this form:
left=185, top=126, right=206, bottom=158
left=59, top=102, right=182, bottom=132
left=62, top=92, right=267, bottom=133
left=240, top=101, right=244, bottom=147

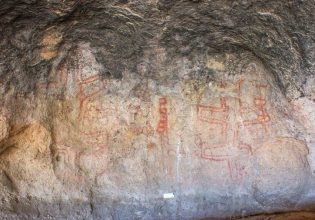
left=254, top=138, right=310, bottom=208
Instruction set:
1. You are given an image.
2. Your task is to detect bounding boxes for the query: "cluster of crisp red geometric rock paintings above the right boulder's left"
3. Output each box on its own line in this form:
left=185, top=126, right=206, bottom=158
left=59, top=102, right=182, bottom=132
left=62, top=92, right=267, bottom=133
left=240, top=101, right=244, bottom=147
left=195, top=64, right=271, bottom=183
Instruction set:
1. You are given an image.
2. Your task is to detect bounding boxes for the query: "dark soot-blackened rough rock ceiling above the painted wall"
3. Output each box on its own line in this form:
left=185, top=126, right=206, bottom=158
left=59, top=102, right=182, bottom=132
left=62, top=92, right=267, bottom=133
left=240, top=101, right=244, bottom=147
left=0, top=0, right=315, bottom=99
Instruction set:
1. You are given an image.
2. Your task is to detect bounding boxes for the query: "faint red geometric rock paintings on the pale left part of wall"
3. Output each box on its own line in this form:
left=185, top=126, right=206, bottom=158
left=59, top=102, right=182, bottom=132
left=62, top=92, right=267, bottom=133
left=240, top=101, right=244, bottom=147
left=38, top=46, right=110, bottom=181
